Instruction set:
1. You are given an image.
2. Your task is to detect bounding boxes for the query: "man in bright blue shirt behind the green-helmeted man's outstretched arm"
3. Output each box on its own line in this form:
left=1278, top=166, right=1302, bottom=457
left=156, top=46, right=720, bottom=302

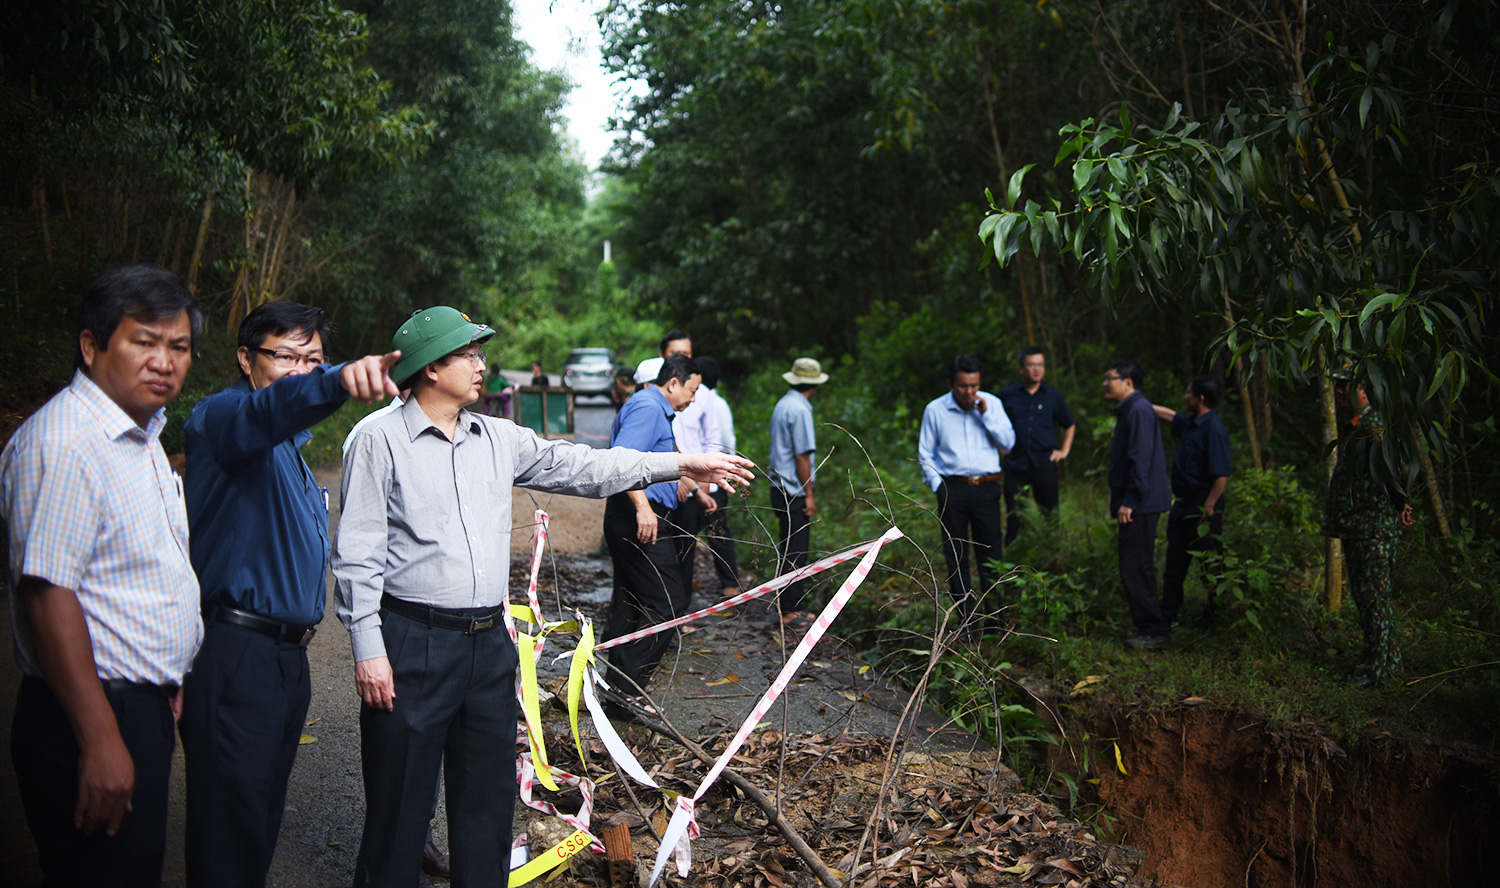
left=605, top=354, right=699, bottom=719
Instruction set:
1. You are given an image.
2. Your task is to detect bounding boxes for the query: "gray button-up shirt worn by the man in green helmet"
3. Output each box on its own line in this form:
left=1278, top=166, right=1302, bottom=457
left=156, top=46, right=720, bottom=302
left=333, top=399, right=678, bottom=662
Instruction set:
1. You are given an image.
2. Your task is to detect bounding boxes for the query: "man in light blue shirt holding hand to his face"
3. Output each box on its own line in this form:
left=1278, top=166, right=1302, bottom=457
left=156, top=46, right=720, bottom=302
left=917, top=354, right=1016, bottom=639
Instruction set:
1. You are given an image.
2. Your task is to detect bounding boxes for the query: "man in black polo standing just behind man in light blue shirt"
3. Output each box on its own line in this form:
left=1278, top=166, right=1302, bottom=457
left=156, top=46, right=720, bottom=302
left=996, top=345, right=1076, bottom=546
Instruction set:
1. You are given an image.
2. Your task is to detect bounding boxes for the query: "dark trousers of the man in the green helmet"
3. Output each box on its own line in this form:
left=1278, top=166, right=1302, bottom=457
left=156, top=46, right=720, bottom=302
left=354, top=609, right=519, bottom=888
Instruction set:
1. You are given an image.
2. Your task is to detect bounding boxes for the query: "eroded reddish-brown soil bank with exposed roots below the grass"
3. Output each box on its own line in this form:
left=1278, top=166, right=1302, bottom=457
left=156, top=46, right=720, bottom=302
left=1055, top=701, right=1500, bottom=888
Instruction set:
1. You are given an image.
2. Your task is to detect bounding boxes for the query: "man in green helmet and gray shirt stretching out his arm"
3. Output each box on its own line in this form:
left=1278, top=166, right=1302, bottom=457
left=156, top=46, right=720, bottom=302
left=333, top=306, right=752, bottom=888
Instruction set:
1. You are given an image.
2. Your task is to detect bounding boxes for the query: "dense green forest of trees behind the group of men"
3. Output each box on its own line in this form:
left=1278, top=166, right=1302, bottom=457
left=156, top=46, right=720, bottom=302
left=0, top=0, right=1500, bottom=750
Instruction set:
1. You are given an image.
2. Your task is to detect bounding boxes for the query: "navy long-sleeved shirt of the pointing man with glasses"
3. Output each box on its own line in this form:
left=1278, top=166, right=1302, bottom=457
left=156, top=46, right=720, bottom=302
left=183, top=365, right=348, bottom=626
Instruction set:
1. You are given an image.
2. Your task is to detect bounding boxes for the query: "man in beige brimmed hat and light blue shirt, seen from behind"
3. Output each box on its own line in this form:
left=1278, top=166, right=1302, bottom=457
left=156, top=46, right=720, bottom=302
left=767, top=357, right=828, bottom=630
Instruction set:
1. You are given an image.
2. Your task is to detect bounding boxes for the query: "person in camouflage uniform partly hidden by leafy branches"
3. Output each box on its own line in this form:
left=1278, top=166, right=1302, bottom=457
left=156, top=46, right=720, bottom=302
left=1323, top=366, right=1412, bottom=686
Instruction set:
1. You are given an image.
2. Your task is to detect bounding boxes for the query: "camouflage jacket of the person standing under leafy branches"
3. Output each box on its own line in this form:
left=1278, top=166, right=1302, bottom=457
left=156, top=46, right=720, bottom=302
left=1323, top=405, right=1401, bottom=540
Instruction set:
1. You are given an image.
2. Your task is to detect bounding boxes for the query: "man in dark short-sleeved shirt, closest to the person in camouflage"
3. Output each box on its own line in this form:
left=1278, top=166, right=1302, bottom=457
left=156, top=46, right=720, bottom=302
left=1154, top=377, right=1230, bottom=626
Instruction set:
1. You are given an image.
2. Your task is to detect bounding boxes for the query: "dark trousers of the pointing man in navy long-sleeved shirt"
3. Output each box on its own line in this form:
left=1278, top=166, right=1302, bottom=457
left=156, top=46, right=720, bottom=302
left=179, top=623, right=312, bottom=888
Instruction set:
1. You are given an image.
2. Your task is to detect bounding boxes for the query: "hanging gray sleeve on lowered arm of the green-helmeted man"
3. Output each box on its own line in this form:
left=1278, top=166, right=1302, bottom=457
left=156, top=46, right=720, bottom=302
left=333, top=432, right=393, bottom=663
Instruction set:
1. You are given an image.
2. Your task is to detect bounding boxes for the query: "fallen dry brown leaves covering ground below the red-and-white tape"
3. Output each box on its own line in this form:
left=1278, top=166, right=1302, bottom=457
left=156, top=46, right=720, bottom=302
left=534, top=728, right=1146, bottom=888
